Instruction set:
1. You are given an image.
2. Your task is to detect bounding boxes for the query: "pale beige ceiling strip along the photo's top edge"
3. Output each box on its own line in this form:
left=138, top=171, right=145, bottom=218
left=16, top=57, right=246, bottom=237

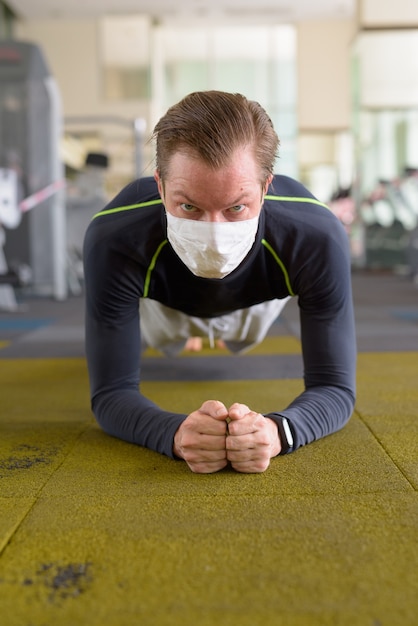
left=7, top=0, right=356, bottom=23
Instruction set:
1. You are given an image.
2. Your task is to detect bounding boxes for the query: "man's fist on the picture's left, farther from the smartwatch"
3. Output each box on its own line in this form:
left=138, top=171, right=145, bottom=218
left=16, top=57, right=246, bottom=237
left=173, top=400, right=228, bottom=474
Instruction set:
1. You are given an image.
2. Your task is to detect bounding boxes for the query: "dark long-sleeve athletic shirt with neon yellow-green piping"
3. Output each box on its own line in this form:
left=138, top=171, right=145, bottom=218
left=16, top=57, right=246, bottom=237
left=83, top=176, right=356, bottom=457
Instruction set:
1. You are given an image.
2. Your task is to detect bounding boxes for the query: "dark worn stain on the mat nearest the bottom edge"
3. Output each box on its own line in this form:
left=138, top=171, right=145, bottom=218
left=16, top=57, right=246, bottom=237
left=22, top=562, right=93, bottom=602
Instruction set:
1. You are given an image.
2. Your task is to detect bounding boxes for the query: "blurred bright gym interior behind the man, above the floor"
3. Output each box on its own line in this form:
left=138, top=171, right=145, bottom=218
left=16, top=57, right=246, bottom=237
left=0, top=0, right=418, bottom=310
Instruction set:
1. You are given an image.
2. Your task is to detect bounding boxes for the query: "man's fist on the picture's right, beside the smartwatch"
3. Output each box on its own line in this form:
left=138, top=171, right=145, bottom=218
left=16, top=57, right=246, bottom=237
left=226, top=402, right=281, bottom=473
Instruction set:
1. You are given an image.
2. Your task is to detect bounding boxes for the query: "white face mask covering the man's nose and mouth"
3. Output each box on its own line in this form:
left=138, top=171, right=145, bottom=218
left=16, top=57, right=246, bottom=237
left=166, top=212, right=258, bottom=278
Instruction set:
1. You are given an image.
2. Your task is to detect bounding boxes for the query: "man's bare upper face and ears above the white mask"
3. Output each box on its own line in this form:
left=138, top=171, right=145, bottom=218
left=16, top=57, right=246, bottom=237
left=155, top=147, right=272, bottom=222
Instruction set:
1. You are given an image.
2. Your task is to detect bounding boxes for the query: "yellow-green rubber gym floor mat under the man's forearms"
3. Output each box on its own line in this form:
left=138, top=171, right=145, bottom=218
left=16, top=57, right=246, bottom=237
left=0, top=352, right=418, bottom=626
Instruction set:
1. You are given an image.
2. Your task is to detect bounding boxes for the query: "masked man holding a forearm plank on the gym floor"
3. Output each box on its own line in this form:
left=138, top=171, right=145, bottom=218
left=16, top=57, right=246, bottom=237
left=84, top=91, right=356, bottom=473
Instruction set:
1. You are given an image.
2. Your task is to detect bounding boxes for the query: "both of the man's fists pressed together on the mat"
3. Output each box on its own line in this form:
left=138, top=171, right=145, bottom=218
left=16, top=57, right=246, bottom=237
left=173, top=400, right=281, bottom=474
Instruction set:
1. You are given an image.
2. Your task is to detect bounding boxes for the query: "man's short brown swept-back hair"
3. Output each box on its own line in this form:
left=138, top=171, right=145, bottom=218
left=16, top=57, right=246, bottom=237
left=153, top=91, right=279, bottom=185
